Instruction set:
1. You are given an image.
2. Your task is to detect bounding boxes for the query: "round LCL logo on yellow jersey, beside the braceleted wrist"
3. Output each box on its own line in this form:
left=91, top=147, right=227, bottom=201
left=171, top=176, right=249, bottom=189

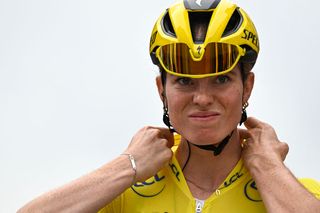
left=131, top=174, right=166, bottom=197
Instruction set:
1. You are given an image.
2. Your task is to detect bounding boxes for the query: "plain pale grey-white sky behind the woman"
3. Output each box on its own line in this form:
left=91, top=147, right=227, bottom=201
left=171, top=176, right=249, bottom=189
left=0, top=0, right=320, bottom=212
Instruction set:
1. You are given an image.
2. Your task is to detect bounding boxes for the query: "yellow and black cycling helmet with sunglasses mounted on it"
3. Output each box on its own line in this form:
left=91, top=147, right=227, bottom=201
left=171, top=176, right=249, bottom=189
left=149, top=0, right=259, bottom=78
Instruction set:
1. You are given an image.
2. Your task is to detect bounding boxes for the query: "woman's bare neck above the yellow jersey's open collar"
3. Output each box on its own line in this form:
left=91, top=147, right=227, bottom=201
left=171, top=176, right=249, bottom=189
left=176, top=130, right=241, bottom=199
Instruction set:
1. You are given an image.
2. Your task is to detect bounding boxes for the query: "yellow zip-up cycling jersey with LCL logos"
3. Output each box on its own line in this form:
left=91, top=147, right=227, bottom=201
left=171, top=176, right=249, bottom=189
left=99, top=136, right=320, bottom=213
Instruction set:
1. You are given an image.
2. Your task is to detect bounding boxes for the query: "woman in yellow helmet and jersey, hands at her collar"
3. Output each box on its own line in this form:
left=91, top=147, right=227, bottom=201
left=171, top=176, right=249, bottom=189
left=20, top=0, right=320, bottom=213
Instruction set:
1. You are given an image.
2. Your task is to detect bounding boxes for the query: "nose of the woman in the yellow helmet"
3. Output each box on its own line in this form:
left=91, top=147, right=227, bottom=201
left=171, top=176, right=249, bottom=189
left=193, top=83, right=214, bottom=107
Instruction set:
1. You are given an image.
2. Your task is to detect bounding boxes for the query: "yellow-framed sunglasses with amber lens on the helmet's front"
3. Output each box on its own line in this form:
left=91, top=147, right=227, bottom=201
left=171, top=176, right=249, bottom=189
left=156, top=42, right=245, bottom=78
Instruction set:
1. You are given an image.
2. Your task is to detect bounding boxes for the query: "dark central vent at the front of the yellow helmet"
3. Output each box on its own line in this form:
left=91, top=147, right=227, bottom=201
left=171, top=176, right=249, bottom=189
left=189, top=11, right=212, bottom=44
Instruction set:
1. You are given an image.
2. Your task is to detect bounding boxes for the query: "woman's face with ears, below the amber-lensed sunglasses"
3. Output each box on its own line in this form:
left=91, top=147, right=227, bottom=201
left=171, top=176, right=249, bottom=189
left=157, top=67, right=254, bottom=145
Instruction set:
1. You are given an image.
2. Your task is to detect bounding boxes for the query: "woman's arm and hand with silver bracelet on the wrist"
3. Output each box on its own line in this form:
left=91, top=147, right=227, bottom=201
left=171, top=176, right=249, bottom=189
left=17, top=126, right=173, bottom=213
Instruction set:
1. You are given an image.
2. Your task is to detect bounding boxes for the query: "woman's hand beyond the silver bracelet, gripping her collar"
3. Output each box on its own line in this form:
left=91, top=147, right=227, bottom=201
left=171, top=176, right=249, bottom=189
left=124, top=126, right=174, bottom=182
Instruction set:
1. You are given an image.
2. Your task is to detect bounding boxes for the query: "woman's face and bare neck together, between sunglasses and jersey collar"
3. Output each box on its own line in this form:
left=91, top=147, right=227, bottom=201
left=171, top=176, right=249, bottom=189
left=157, top=66, right=254, bottom=199
